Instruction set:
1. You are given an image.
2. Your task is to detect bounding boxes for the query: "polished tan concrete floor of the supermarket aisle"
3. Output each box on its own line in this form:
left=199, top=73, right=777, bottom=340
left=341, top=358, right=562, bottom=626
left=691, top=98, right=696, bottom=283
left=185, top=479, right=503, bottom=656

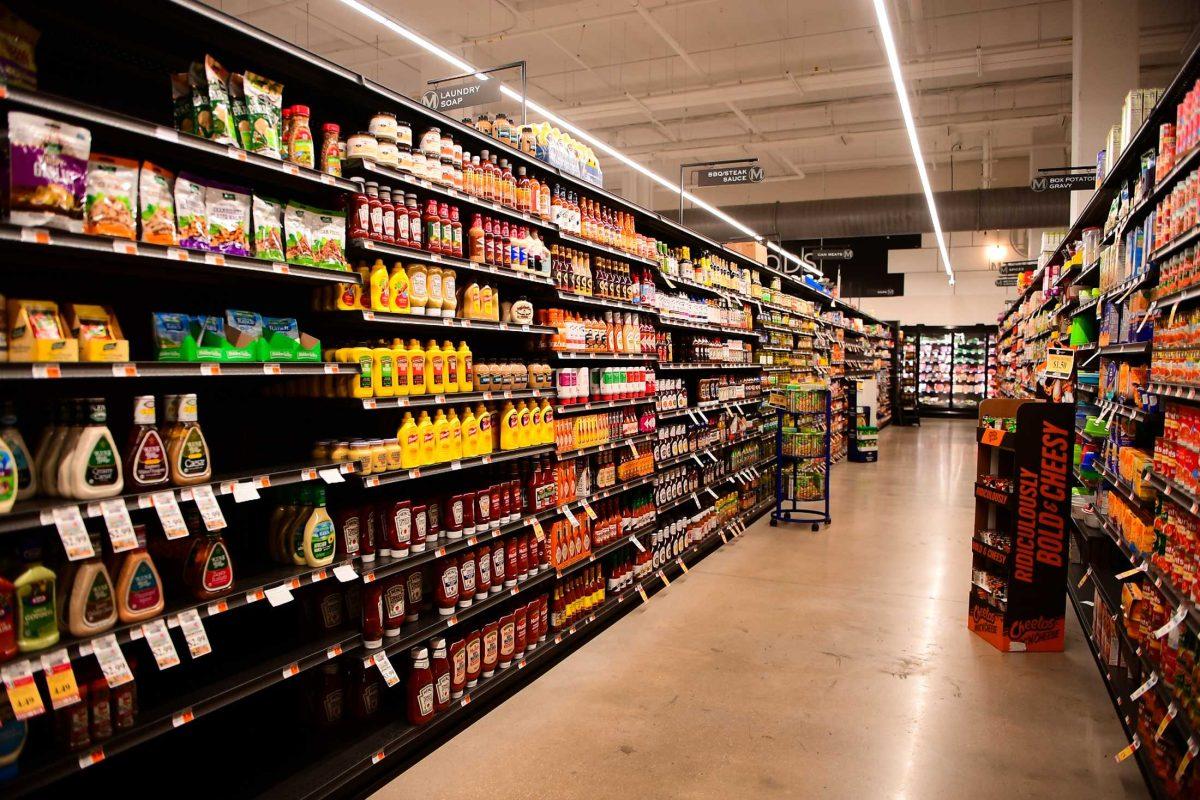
left=376, top=420, right=1146, bottom=800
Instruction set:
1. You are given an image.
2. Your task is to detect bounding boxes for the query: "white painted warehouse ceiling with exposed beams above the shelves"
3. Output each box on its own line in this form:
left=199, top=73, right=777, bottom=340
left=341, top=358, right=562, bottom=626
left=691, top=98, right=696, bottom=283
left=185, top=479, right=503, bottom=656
left=201, top=0, right=1200, bottom=207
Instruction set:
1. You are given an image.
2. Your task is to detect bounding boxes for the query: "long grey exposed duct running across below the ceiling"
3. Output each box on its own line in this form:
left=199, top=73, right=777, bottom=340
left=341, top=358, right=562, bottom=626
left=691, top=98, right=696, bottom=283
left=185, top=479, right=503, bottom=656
left=662, top=186, right=1070, bottom=241
